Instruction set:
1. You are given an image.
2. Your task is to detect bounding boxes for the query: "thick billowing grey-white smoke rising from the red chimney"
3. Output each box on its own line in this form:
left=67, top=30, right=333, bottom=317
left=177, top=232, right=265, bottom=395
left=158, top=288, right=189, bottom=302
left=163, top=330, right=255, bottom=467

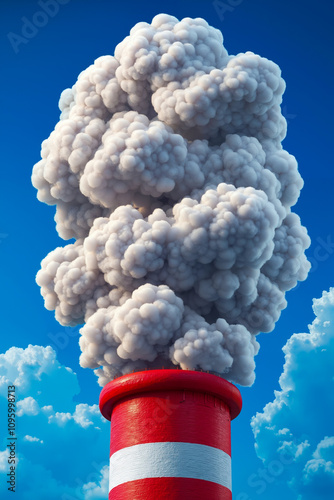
left=32, top=14, right=310, bottom=385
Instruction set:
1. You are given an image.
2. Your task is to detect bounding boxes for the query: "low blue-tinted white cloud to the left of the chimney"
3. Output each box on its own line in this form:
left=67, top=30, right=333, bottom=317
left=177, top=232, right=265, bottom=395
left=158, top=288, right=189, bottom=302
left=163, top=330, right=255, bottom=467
left=0, top=346, right=110, bottom=500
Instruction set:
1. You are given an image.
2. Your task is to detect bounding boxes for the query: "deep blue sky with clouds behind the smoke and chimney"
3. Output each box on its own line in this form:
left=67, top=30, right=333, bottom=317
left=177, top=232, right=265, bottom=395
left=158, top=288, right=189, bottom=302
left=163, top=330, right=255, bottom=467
left=0, top=0, right=334, bottom=500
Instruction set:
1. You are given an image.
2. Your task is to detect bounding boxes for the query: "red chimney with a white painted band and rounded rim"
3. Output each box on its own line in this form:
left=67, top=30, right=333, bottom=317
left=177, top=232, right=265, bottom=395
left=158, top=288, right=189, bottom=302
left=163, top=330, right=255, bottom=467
left=100, top=370, right=242, bottom=500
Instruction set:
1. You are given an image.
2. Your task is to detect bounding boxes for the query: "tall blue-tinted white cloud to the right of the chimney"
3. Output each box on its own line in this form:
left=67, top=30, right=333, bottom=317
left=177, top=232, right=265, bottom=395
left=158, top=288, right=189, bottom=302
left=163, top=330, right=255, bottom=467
left=252, top=288, right=334, bottom=500
